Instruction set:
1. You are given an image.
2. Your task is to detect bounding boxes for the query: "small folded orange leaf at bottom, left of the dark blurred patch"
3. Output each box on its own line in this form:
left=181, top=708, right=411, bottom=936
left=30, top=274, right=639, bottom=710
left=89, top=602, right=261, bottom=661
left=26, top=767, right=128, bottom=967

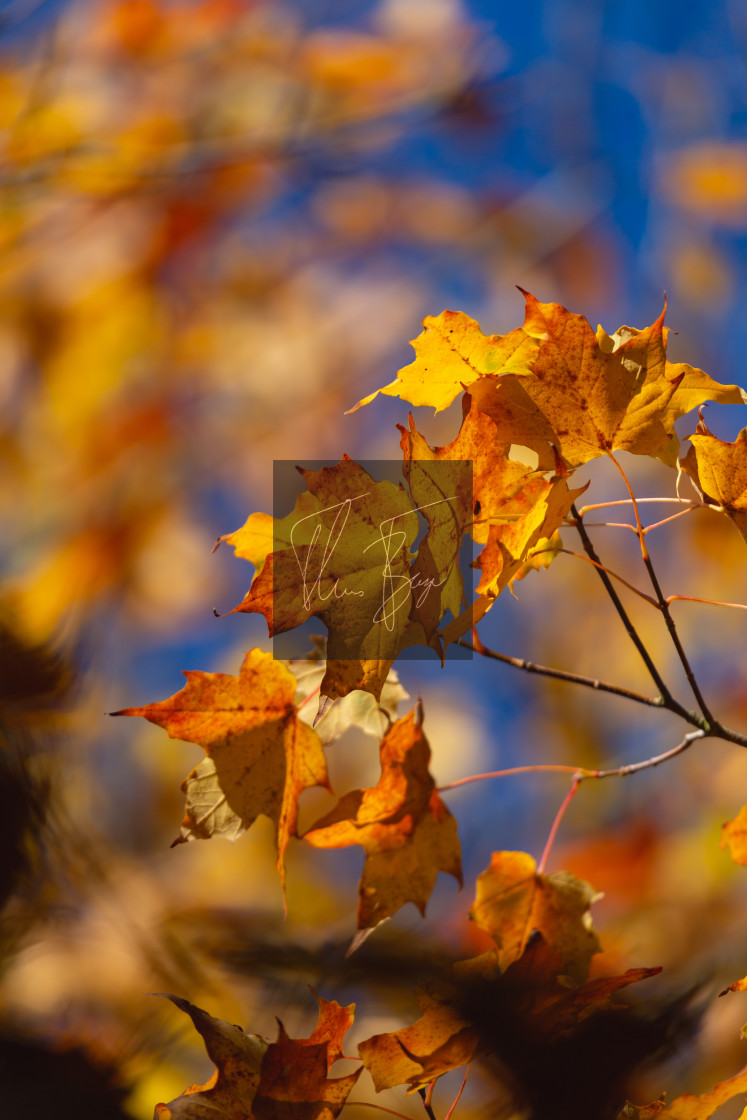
left=358, top=991, right=479, bottom=1093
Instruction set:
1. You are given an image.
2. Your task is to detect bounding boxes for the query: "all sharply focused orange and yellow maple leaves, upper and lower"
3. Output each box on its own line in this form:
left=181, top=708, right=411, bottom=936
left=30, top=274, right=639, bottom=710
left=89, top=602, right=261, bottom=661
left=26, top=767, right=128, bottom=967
left=120, top=295, right=747, bottom=1120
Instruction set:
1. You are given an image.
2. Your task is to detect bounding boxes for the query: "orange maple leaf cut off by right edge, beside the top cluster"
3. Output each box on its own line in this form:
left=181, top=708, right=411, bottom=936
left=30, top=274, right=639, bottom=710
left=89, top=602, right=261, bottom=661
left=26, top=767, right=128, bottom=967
left=680, top=416, right=747, bottom=541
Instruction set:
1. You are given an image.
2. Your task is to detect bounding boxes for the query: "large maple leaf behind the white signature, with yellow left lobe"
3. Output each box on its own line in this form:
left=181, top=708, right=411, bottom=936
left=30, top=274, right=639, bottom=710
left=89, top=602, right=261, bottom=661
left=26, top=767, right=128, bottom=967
left=220, top=457, right=423, bottom=699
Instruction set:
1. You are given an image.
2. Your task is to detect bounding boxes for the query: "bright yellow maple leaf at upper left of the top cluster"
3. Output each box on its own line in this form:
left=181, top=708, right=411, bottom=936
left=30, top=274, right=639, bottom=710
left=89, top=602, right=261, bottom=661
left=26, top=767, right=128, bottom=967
left=349, top=311, right=538, bottom=412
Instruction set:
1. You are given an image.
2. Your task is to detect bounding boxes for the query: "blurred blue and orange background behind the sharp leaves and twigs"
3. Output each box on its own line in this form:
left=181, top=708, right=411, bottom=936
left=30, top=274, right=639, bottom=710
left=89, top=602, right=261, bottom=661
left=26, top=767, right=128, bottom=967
left=0, top=0, right=747, bottom=1118
